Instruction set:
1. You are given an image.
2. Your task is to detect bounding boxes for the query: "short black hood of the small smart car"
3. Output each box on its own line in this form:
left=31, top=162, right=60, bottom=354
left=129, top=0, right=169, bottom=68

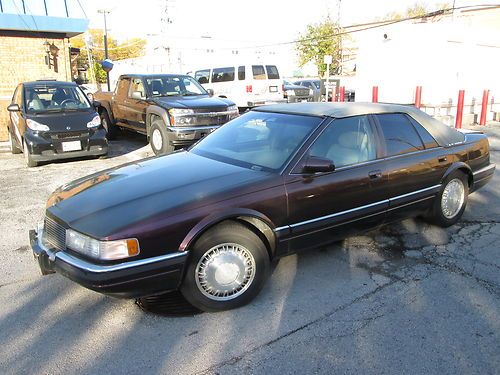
left=26, top=110, right=97, bottom=132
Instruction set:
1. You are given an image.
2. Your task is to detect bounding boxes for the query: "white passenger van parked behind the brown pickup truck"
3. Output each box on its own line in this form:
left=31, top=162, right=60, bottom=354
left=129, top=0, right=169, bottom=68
left=194, top=64, right=286, bottom=109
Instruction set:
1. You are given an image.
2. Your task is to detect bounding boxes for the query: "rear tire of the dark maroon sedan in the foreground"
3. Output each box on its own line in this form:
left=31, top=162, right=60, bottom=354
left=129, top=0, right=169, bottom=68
left=426, top=171, right=469, bottom=228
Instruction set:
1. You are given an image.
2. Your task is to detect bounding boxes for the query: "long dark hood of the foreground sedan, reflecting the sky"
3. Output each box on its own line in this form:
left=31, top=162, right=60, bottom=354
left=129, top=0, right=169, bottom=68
left=47, top=151, right=276, bottom=238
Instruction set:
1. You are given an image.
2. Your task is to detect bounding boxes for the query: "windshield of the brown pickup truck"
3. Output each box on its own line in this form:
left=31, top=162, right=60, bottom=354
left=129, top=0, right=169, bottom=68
left=146, top=76, right=207, bottom=97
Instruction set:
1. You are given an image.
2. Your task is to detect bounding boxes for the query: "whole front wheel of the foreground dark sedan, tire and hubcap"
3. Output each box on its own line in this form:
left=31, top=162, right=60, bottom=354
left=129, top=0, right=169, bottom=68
left=180, top=221, right=270, bottom=312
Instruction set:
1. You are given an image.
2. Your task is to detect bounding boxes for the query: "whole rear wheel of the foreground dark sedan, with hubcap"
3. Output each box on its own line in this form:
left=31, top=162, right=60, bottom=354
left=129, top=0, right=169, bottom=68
left=429, top=171, right=469, bottom=227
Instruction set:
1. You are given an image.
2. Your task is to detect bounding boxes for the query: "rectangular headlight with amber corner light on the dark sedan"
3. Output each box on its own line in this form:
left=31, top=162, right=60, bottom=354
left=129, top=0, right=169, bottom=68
left=66, top=229, right=141, bottom=260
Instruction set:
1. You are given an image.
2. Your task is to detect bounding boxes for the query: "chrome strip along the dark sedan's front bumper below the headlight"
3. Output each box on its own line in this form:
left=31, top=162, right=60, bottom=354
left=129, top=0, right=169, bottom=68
left=56, top=251, right=187, bottom=273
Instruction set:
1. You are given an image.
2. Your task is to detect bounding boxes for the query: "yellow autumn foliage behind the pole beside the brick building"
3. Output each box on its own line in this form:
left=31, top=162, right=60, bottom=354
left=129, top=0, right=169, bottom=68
left=70, top=29, right=146, bottom=83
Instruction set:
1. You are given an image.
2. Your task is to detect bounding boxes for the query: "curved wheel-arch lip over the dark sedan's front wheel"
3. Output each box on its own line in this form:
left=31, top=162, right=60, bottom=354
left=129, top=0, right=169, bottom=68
left=179, top=208, right=276, bottom=256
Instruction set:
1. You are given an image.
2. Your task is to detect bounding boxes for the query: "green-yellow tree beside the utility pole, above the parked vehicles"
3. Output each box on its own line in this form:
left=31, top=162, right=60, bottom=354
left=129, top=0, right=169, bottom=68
left=295, top=17, right=342, bottom=77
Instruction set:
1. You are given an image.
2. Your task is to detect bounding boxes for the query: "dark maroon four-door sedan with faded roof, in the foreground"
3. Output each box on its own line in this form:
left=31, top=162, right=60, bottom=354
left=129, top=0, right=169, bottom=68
left=30, top=103, right=495, bottom=311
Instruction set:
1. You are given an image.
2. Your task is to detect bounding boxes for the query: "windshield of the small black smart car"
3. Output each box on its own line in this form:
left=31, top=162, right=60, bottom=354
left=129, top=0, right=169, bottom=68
left=24, top=84, right=90, bottom=113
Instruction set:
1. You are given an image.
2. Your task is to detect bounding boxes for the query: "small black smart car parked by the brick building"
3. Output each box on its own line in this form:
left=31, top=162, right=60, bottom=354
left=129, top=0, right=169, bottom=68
left=7, top=81, right=108, bottom=167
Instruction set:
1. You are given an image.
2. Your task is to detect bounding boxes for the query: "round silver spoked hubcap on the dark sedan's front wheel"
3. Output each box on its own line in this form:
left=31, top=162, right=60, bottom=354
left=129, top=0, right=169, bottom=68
left=195, top=243, right=255, bottom=301
